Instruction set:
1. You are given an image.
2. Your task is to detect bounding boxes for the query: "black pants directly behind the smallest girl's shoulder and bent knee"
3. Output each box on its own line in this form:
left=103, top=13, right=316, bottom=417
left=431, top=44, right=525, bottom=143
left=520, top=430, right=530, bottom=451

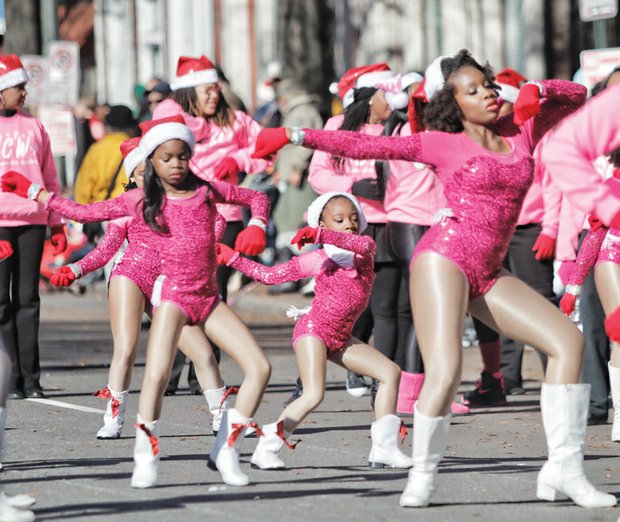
left=352, top=223, right=401, bottom=360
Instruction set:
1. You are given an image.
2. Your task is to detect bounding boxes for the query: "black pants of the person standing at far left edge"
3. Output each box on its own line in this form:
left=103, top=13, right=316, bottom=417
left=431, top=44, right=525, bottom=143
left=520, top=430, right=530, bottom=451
left=0, top=225, right=46, bottom=390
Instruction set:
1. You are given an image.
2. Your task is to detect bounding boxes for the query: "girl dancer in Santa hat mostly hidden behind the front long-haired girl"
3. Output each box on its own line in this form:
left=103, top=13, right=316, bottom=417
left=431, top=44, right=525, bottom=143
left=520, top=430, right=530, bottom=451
left=50, top=138, right=228, bottom=439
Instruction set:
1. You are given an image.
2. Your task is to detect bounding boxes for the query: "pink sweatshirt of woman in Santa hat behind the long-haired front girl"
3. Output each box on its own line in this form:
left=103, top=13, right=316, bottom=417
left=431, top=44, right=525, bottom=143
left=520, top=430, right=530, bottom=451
left=153, top=99, right=271, bottom=221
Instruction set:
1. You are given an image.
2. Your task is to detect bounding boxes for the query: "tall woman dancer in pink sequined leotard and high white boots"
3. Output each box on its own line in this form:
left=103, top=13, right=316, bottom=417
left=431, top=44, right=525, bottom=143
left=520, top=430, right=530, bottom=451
left=251, top=51, right=616, bottom=507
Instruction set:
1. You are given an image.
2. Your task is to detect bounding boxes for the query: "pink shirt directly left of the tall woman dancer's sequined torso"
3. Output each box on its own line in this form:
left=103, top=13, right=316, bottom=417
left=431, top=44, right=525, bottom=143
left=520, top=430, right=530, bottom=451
left=383, top=125, right=446, bottom=226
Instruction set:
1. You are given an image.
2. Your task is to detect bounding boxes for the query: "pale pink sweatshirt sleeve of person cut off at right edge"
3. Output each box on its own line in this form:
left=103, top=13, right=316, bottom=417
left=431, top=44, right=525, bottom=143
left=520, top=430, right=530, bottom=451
left=542, top=85, right=620, bottom=225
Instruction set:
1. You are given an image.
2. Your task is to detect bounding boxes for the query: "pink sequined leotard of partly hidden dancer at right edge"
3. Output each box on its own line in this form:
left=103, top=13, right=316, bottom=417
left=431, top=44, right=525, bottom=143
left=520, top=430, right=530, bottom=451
left=567, top=176, right=620, bottom=286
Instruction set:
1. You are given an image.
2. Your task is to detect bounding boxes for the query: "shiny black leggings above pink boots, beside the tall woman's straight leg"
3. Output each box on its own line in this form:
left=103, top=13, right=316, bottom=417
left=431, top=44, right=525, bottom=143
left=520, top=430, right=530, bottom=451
left=387, top=222, right=428, bottom=373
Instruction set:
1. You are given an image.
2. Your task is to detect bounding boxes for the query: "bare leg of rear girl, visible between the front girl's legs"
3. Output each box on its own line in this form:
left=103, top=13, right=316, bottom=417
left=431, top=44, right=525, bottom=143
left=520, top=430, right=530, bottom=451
left=179, top=326, right=224, bottom=390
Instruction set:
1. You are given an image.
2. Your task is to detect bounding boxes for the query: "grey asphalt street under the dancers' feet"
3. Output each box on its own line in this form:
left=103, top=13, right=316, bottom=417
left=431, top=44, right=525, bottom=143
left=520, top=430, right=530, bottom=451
left=2, top=286, right=620, bottom=522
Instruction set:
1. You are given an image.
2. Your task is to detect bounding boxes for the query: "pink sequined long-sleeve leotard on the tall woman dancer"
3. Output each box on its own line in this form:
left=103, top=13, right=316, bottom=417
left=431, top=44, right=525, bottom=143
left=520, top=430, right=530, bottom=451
left=303, top=80, right=586, bottom=299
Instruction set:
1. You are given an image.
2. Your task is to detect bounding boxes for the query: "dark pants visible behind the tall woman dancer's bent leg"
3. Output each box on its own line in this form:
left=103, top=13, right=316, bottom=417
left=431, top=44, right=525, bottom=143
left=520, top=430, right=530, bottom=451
left=474, top=224, right=555, bottom=388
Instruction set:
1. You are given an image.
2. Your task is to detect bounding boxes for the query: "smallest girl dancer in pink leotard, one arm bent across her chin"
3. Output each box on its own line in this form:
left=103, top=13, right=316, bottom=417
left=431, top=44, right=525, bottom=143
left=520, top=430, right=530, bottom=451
left=218, top=192, right=412, bottom=469
